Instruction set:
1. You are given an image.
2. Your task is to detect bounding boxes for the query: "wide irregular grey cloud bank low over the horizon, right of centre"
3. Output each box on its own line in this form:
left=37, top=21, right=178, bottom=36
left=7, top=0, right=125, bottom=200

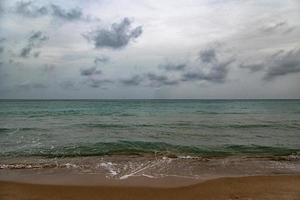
left=120, top=48, right=235, bottom=87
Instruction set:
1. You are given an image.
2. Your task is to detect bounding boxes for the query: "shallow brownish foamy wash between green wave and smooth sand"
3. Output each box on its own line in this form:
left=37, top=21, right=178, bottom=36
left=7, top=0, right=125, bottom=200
left=0, top=155, right=300, bottom=185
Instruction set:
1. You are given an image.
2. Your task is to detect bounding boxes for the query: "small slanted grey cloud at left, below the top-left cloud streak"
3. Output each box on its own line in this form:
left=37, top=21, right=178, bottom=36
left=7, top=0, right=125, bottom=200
left=20, top=31, right=49, bottom=58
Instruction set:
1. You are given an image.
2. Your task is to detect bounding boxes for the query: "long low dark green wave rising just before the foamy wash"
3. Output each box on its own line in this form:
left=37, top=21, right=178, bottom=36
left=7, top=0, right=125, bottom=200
left=0, top=141, right=300, bottom=157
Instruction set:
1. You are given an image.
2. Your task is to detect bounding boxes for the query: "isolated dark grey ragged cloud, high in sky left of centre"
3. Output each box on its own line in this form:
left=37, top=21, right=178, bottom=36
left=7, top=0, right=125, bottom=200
left=83, top=18, right=143, bottom=49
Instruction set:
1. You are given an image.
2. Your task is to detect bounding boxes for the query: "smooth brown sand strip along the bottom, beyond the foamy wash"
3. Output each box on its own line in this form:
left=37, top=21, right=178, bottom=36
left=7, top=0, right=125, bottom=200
left=0, top=175, right=300, bottom=200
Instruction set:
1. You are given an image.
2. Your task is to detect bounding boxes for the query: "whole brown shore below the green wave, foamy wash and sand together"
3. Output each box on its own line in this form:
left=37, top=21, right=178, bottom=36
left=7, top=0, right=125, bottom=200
left=0, top=156, right=300, bottom=200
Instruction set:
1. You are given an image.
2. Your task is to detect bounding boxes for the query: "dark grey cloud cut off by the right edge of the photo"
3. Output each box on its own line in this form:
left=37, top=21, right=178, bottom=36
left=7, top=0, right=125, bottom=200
left=264, top=49, right=300, bottom=81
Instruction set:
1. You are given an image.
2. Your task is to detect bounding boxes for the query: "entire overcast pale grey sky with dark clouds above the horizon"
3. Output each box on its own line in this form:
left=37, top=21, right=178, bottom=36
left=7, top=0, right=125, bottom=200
left=0, top=0, right=300, bottom=99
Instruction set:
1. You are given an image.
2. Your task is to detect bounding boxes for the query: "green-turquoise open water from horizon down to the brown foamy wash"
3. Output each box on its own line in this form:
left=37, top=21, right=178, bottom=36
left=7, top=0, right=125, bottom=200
left=0, top=100, right=300, bottom=157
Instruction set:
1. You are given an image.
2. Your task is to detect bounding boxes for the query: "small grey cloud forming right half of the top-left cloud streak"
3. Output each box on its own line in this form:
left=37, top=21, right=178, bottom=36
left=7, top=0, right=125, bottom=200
left=51, top=4, right=83, bottom=21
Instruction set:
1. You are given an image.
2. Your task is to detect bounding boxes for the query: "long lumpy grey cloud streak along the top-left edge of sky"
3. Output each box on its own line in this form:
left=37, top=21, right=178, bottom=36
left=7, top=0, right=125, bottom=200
left=15, top=1, right=87, bottom=21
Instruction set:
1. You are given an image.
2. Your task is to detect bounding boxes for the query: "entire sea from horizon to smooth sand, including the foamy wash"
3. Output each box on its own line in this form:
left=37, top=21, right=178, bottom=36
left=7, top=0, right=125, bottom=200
left=0, top=99, right=300, bottom=180
